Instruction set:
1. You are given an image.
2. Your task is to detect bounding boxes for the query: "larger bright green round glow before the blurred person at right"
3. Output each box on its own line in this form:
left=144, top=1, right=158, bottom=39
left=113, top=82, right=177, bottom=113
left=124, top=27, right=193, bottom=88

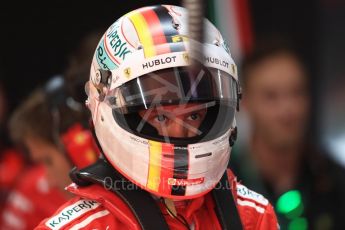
left=276, top=190, right=304, bottom=219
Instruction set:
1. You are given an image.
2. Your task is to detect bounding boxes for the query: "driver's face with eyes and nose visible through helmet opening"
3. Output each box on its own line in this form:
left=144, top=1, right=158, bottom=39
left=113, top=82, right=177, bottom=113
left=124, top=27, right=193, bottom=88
left=139, top=103, right=207, bottom=138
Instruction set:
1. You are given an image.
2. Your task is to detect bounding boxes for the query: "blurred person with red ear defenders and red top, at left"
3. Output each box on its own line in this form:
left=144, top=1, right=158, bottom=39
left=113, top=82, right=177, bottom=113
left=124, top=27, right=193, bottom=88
left=0, top=30, right=101, bottom=230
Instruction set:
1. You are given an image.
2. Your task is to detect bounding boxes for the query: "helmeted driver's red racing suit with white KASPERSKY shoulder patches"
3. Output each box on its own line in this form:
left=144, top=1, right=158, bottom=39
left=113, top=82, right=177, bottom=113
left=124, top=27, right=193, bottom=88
left=36, top=170, right=279, bottom=230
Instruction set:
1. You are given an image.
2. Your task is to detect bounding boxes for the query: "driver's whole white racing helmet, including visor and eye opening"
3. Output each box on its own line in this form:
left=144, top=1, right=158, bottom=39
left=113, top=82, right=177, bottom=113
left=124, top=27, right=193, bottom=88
left=86, top=5, right=239, bottom=199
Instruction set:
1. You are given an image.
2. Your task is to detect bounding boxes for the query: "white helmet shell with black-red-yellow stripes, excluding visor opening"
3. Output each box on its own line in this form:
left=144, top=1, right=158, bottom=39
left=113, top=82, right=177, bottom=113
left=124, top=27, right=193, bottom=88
left=87, top=5, right=237, bottom=199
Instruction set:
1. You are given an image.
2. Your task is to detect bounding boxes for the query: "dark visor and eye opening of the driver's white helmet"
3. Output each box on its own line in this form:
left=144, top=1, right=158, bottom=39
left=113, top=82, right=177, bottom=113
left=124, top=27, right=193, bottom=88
left=106, top=67, right=238, bottom=143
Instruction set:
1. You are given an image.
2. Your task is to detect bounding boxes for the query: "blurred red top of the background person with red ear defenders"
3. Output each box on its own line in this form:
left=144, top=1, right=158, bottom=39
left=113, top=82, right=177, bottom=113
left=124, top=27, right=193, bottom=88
left=0, top=166, right=68, bottom=230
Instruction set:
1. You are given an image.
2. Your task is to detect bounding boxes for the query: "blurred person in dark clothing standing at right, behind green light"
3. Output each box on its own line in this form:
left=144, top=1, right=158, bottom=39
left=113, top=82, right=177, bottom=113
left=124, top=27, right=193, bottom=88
left=230, top=40, right=345, bottom=230
